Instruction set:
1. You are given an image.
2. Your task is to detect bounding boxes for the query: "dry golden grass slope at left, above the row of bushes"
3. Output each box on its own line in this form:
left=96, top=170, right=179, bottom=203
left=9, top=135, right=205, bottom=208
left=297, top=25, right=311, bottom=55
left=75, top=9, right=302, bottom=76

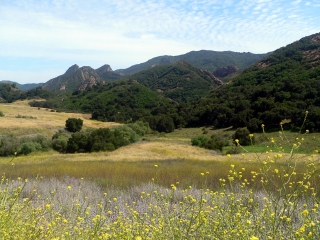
left=0, top=100, right=119, bottom=137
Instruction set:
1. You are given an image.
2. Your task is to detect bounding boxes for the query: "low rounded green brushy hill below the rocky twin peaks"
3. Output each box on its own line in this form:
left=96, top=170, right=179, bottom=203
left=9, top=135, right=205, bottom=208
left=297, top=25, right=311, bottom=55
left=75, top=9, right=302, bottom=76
left=42, top=80, right=184, bottom=130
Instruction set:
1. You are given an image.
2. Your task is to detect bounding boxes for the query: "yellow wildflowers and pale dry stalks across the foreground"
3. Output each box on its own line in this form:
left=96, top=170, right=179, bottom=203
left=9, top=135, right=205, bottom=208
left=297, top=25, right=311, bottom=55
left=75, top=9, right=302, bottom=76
left=0, top=157, right=320, bottom=239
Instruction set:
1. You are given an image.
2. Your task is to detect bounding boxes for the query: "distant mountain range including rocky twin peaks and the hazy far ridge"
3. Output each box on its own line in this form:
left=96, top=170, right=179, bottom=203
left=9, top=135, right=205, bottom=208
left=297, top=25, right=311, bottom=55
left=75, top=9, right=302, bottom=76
left=42, top=50, right=267, bottom=92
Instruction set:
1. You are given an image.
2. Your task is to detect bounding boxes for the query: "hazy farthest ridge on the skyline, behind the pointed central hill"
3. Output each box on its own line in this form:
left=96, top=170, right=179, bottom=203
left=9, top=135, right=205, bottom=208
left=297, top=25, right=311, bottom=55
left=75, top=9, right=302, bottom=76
left=115, top=50, right=266, bottom=76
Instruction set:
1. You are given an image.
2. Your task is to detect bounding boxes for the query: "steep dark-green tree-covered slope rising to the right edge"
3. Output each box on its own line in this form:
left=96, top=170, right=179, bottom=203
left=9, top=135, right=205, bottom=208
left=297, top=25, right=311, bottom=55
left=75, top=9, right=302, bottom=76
left=189, top=33, right=320, bottom=131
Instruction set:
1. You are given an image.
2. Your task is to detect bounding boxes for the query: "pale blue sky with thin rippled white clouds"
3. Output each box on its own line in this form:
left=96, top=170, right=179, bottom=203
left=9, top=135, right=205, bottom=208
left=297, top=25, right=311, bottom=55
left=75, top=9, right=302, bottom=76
left=0, top=0, right=320, bottom=84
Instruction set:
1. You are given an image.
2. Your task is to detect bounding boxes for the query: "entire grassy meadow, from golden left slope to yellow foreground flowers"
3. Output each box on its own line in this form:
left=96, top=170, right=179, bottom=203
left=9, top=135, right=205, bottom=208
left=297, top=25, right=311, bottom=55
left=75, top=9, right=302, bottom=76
left=0, top=101, right=320, bottom=240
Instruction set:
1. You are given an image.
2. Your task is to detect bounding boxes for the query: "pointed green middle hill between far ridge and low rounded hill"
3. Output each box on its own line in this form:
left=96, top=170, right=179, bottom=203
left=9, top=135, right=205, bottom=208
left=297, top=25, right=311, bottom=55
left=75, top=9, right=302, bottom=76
left=130, top=61, right=223, bottom=102
